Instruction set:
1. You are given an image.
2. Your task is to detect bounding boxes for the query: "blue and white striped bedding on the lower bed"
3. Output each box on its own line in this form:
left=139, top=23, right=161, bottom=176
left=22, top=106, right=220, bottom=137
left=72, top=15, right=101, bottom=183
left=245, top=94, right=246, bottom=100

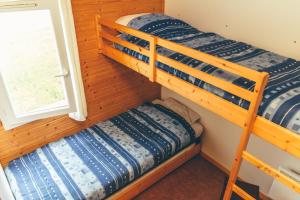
left=5, top=103, right=195, bottom=200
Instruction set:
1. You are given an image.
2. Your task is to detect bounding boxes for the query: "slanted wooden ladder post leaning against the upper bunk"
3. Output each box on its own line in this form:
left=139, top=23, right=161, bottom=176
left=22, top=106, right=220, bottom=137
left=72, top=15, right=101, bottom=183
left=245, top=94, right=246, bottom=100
left=223, top=73, right=269, bottom=200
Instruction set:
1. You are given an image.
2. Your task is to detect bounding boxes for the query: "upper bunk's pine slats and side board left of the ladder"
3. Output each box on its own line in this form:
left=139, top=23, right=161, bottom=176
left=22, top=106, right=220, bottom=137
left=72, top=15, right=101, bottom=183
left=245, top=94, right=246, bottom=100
left=97, top=17, right=268, bottom=127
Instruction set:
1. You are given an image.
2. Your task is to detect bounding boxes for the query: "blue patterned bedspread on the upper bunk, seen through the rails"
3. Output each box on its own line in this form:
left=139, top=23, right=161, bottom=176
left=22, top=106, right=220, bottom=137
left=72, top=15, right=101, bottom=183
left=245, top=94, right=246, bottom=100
left=118, top=14, right=300, bottom=133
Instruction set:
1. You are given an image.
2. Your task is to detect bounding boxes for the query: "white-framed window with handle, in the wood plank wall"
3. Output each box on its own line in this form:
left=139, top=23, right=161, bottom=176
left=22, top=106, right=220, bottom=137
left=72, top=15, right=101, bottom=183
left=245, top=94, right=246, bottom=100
left=0, top=0, right=86, bottom=129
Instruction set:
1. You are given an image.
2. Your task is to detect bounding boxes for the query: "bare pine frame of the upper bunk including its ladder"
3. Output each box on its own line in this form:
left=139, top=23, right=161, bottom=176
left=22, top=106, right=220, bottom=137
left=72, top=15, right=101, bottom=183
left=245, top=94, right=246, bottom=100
left=96, top=15, right=300, bottom=200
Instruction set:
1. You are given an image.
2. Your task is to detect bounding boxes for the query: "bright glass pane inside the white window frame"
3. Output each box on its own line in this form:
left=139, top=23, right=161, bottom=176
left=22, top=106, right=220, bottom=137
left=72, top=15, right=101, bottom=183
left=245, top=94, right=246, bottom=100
left=0, top=10, right=68, bottom=116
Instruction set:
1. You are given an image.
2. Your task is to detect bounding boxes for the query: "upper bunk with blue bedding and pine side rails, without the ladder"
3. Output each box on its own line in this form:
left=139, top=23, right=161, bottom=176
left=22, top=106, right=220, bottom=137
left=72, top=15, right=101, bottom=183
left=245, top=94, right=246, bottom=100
left=97, top=14, right=300, bottom=157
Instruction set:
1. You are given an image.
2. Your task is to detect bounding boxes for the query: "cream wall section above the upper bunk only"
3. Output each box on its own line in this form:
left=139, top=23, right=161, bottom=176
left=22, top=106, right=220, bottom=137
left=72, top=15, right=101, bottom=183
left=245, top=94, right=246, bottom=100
left=165, top=0, right=300, bottom=60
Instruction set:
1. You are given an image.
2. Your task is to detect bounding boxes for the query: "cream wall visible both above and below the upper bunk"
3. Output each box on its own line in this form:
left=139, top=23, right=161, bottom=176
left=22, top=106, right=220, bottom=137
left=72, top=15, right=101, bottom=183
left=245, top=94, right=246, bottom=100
left=162, top=0, right=300, bottom=193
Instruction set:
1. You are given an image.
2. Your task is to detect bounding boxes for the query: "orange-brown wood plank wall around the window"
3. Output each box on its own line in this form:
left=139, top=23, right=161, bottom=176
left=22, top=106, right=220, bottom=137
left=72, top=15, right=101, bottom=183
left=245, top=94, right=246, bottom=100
left=0, top=0, right=164, bottom=166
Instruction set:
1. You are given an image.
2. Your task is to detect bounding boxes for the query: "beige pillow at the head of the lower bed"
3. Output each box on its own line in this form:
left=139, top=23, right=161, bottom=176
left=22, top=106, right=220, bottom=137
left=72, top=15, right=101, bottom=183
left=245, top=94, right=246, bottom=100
left=153, top=98, right=200, bottom=125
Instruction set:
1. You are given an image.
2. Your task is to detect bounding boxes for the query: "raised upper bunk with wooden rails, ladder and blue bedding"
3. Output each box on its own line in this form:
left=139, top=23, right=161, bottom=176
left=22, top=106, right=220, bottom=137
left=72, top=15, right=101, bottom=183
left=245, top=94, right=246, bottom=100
left=96, top=14, right=300, bottom=200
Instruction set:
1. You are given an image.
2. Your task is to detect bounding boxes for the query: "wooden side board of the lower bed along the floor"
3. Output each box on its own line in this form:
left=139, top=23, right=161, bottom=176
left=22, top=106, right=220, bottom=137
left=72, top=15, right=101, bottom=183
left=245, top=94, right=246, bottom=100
left=108, top=144, right=200, bottom=200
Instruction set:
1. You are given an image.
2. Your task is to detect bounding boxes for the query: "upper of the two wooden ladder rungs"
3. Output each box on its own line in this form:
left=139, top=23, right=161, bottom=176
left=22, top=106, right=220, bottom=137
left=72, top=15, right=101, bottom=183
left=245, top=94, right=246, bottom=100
left=243, top=151, right=300, bottom=193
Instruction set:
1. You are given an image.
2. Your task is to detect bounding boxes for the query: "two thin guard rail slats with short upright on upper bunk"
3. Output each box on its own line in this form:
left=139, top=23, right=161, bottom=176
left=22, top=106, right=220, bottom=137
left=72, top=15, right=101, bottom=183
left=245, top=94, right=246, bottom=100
left=99, top=20, right=267, bottom=99
